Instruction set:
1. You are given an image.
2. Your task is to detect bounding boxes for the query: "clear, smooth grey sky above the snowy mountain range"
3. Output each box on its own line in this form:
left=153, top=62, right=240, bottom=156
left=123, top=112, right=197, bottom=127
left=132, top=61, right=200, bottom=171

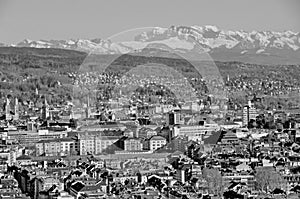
left=0, top=0, right=300, bottom=43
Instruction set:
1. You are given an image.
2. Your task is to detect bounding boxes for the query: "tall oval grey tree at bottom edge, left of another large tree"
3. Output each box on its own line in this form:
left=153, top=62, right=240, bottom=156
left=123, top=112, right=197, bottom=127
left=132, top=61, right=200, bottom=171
left=202, top=168, right=224, bottom=197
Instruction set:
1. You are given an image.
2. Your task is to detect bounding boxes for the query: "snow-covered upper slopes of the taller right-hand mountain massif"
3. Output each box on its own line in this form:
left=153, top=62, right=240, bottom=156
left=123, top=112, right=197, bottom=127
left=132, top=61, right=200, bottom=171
left=135, top=26, right=300, bottom=52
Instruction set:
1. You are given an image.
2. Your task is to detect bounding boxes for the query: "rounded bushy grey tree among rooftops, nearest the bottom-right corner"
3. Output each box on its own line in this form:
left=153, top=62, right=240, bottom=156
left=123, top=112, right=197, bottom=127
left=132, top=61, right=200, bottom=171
left=255, top=168, right=286, bottom=193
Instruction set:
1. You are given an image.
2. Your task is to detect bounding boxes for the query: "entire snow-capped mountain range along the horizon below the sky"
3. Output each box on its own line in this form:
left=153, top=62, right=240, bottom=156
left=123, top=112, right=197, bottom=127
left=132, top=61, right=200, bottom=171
left=4, top=25, right=300, bottom=64
